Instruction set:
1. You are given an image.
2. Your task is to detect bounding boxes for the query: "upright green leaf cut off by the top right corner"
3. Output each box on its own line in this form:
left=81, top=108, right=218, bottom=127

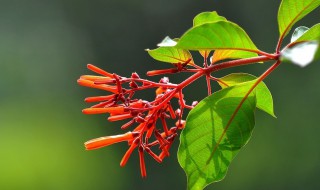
left=278, top=0, right=320, bottom=38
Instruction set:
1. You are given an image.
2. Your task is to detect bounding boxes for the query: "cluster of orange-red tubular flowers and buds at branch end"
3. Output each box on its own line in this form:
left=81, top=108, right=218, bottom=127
left=78, top=64, right=192, bottom=177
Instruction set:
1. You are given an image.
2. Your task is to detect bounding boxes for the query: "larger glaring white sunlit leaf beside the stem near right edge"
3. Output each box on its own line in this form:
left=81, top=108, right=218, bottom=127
left=281, top=41, right=319, bottom=67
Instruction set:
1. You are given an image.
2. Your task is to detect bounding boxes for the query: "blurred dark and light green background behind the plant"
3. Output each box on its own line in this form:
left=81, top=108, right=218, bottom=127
left=0, top=0, right=320, bottom=190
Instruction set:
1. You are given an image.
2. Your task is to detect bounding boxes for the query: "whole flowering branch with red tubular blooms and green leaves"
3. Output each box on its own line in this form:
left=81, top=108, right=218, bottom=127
left=78, top=0, right=320, bottom=189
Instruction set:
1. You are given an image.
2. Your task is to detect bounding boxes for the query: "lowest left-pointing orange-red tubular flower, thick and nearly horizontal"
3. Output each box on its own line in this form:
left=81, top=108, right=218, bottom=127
left=84, top=132, right=139, bottom=150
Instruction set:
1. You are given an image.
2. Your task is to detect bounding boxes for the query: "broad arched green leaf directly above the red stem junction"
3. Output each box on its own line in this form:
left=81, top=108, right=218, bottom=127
left=176, top=21, right=258, bottom=55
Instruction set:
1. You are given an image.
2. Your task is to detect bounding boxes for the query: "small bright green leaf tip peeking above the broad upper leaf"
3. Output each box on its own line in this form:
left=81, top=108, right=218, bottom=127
left=193, top=11, right=227, bottom=27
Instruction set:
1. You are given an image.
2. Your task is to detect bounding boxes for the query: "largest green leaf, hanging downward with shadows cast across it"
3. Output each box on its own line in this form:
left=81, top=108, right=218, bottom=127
left=178, top=82, right=256, bottom=190
